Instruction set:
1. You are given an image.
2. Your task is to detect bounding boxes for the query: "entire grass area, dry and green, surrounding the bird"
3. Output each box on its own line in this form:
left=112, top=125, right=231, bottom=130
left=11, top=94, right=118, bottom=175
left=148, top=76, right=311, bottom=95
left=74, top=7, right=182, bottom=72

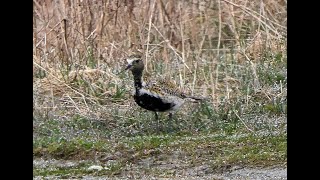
left=33, top=0, right=287, bottom=178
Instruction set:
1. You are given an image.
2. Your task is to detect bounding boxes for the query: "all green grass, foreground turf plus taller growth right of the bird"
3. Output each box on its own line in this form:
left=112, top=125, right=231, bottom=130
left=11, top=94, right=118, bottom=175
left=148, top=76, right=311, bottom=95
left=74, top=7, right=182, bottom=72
left=33, top=53, right=287, bottom=178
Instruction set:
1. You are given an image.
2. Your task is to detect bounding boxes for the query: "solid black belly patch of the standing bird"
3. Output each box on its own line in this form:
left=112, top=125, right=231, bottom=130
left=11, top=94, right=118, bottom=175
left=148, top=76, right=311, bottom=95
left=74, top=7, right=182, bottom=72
left=134, top=94, right=174, bottom=112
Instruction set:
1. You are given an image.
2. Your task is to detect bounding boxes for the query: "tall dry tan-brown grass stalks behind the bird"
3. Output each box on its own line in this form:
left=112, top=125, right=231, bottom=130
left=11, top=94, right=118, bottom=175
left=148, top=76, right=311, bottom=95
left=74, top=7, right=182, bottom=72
left=33, top=0, right=287, bottom=126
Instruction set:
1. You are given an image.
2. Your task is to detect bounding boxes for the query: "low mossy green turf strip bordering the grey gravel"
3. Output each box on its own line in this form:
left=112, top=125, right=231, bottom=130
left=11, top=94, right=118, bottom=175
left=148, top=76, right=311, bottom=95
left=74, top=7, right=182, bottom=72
left=34, top=127, right=287, bottom=178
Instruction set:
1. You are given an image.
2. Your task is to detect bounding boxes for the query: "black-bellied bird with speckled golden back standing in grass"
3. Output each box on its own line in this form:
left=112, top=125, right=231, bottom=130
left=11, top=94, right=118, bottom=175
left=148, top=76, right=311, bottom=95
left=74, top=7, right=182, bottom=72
left=124, top=54, right=205, bottom=125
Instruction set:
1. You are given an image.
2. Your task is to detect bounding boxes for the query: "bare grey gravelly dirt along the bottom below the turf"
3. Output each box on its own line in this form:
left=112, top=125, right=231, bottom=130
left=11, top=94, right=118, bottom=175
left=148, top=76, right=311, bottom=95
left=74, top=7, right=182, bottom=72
left=33, top=159, right=287, bottom=180
